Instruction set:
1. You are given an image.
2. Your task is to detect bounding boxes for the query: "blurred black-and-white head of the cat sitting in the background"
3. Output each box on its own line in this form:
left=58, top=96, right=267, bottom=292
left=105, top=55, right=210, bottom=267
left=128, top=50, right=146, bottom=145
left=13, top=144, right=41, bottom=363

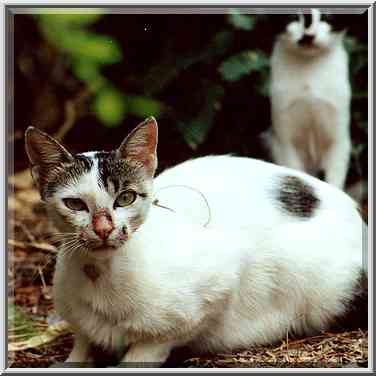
left=279, top=8, right=344, bottom=56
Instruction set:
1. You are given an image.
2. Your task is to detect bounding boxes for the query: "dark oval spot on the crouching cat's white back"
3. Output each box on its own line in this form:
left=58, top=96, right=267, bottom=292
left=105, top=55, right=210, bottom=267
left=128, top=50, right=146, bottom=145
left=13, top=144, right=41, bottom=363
left=276, top=176, right=320, bottom=218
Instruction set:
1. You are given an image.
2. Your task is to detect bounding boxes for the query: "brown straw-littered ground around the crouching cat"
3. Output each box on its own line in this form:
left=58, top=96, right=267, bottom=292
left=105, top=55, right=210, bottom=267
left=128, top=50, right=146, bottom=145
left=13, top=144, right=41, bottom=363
left=8, top=170, right=368, bottom=368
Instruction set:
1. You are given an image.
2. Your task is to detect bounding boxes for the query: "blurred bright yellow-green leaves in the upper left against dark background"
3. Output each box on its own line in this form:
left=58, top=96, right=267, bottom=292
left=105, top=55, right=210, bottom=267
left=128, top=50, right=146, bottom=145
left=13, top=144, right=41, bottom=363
left=36, top=13, right=164, bottom=127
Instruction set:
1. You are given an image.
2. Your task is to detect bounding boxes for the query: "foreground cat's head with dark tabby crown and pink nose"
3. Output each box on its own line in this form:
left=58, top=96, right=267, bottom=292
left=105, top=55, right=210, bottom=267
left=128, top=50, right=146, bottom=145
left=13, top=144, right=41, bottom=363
left=25, top=118, right=158, bottom=257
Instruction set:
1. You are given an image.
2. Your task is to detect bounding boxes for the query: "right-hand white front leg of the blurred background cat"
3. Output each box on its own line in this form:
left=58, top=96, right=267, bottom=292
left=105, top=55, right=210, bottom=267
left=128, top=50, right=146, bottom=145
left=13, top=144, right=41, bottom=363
left=324, top=140, right=351, bottom=189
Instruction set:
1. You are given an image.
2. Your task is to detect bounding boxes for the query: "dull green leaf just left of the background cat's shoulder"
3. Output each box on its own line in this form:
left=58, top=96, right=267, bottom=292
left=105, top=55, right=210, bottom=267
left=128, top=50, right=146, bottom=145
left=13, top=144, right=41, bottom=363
left=218, top=50, right=269, bottom=81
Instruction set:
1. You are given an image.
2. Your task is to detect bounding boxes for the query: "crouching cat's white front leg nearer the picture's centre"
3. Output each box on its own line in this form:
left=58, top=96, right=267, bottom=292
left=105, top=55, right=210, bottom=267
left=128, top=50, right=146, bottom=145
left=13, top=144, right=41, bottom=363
left=120, top=342, right=174, bottom=367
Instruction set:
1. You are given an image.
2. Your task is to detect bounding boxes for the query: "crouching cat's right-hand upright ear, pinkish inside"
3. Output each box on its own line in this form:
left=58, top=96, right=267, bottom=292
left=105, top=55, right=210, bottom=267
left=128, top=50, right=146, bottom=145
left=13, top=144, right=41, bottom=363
left=116, top=117, right=158, bottom=176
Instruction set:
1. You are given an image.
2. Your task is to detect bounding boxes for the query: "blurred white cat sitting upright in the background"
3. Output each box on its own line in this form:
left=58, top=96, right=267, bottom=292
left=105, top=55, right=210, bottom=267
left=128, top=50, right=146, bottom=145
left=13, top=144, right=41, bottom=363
left=270, top=9, right=351, bottom=189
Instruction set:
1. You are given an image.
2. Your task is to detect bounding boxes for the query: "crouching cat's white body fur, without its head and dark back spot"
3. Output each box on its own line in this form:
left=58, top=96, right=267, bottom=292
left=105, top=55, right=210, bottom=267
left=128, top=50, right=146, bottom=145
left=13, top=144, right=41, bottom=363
left=54, top=156, right=363, bottom=362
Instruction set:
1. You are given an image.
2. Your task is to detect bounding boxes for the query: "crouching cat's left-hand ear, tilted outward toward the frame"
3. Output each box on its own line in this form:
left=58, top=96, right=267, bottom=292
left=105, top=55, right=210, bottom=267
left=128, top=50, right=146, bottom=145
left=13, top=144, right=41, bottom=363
left=25, top=127, right=73, bottom=190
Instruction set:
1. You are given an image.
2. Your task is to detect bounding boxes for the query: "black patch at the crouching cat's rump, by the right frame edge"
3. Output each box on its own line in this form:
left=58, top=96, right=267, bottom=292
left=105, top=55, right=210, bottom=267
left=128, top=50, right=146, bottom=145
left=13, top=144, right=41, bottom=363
left=330, top=269, right=368, bottom=331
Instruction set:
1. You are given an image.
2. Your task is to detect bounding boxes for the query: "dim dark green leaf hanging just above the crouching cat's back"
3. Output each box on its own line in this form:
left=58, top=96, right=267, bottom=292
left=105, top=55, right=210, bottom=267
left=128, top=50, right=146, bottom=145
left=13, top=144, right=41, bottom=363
left=177, top=85, right=224, bottom=150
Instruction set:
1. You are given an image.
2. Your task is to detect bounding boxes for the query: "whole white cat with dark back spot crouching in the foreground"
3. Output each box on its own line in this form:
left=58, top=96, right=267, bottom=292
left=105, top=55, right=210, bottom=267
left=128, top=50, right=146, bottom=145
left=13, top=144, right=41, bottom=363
left=26, top=118, right=367, bottom=366
